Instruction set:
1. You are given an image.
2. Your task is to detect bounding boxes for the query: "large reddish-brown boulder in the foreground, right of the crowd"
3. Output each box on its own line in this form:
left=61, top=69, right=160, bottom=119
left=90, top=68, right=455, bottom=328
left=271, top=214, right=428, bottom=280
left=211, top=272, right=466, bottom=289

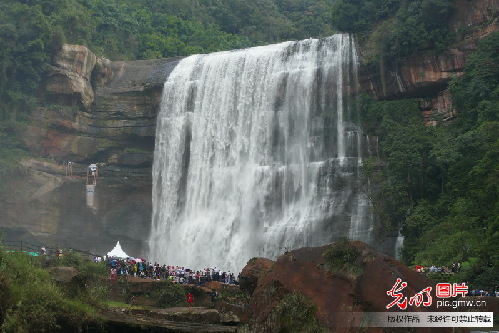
left=244, top=242, right=466, bottom=332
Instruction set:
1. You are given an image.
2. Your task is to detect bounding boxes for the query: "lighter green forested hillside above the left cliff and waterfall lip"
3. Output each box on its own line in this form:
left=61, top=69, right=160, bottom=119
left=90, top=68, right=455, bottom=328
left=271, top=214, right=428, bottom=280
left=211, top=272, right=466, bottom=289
left=0, top=0, right=340, bottom=178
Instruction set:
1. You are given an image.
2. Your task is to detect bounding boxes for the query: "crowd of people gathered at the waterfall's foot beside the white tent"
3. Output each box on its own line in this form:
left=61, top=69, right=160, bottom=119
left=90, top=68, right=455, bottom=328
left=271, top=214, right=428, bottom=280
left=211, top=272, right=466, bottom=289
left=107, top=258, right=239, bottom=286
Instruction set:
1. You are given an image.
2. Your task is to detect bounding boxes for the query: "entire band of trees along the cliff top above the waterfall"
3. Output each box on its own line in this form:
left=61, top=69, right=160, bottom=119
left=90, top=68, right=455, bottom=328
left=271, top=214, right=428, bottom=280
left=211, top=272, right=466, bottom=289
left=0, top=0, right=453, bottom=114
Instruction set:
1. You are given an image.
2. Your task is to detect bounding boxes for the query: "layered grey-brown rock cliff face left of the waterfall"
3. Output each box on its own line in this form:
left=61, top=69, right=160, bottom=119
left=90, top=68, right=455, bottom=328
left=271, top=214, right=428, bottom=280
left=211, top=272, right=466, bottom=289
left=0, top=45, right=184, bottom=256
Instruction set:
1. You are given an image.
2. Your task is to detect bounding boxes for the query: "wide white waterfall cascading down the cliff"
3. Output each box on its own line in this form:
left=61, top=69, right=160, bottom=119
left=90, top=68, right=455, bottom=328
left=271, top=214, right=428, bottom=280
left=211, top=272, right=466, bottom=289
left=150, top=34, right=372, bottom=271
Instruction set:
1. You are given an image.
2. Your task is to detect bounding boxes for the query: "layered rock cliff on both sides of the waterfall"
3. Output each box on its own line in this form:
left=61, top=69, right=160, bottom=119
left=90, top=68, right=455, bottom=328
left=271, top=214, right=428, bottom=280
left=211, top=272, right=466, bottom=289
left=0, top=0, right=499, bottom=255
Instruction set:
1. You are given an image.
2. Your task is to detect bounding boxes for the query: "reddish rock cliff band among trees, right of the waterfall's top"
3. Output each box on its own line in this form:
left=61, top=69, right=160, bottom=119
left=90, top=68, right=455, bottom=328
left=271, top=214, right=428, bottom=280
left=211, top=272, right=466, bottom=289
left=360, top=0, right=499, bottom=118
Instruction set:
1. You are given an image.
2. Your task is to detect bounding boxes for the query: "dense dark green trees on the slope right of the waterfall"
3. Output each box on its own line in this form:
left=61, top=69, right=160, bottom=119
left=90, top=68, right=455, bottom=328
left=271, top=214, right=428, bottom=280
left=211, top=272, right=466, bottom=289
left=363, top=32, right=499, bottom=290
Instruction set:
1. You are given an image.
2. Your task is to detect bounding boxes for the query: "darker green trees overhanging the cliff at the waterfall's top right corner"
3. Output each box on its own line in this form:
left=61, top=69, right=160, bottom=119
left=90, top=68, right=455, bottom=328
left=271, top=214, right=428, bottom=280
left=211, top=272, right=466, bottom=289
left=332, top=0, right=454, bottom=61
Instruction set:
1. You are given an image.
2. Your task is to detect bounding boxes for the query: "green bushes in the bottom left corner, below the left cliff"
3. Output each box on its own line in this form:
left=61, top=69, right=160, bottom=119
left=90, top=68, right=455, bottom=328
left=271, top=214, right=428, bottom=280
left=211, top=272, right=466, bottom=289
left=0, top=247, right=107, bottom=332
